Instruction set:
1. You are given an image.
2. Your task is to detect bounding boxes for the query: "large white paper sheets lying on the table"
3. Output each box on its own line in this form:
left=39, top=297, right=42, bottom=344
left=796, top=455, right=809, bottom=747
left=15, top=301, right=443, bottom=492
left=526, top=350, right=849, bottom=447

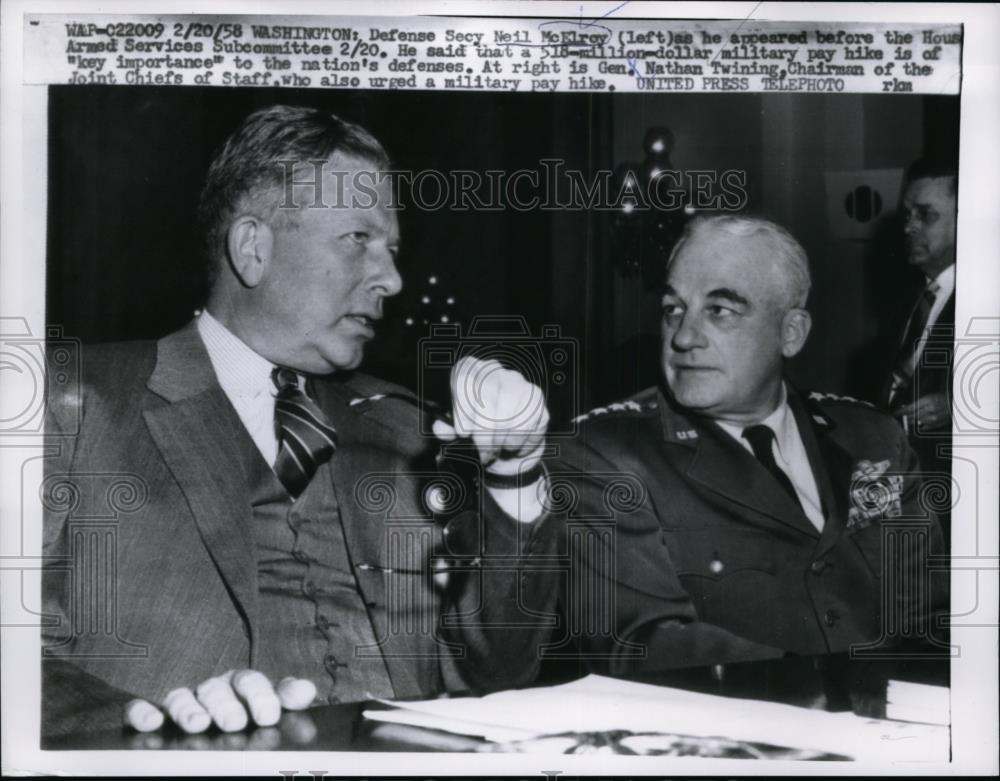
left=365, top=675, right=949, bottom=762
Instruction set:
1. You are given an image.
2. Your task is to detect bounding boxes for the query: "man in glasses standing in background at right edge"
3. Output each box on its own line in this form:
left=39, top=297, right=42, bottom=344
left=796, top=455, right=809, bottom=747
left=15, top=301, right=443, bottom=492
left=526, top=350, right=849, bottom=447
left=881, top=159, right=958, bottom=539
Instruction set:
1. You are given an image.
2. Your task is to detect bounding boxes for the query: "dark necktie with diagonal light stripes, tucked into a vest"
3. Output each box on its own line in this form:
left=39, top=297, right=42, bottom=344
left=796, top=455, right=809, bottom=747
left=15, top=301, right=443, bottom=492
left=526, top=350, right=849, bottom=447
left=271, top=367, right=337, bottom=498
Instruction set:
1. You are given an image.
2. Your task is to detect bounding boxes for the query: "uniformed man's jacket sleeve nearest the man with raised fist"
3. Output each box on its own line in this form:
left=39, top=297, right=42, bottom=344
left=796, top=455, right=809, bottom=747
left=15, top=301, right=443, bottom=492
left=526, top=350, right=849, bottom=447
left=552, top=436, right=783, bottom=675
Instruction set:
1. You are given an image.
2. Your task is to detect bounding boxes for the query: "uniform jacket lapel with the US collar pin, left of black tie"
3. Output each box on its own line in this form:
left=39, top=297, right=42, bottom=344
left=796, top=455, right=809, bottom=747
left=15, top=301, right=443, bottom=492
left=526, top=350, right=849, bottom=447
left=661, top=390, right=818, bottom=537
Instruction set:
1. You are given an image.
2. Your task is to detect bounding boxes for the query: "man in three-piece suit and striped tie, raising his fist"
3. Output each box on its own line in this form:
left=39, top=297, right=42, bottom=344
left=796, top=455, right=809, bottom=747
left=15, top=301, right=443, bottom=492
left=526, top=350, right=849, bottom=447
left=43, top=106, right=548, bottom=733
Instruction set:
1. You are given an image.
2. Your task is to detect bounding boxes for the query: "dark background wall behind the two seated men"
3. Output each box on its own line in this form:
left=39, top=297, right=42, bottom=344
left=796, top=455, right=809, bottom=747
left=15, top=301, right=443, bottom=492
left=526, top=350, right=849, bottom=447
left=47, top=86, right=958, bottom=424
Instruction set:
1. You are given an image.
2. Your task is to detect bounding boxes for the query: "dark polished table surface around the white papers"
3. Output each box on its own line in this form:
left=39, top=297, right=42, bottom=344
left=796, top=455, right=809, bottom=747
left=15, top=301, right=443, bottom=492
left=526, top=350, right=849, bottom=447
left=42, top=655, right=949, bottom=752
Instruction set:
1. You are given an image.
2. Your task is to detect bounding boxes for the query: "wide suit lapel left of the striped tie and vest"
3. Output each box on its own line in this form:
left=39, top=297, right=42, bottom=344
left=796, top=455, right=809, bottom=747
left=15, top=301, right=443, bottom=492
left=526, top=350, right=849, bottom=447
left=144, top=322, right=257, bottom=664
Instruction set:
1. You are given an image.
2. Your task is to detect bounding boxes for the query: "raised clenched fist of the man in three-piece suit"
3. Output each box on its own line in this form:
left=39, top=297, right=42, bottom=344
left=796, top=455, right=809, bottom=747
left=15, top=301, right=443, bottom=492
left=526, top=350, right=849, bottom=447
left=434, top=357, right=549, bottom=475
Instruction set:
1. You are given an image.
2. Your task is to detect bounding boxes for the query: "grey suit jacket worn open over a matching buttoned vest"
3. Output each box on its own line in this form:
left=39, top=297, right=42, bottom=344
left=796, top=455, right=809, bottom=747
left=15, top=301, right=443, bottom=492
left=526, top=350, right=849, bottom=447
left=43, top=323, right=548, bottom=726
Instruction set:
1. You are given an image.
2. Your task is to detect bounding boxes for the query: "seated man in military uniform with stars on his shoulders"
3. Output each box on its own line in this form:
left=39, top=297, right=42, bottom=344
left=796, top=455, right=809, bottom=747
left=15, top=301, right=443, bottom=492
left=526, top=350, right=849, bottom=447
left=542, top=216, right=941, bottom=673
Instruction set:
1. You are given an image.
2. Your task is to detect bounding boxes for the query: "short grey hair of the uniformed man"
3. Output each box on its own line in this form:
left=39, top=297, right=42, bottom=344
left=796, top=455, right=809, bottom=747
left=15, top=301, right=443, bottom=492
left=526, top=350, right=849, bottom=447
left=667, top=214, right=812, bottom=309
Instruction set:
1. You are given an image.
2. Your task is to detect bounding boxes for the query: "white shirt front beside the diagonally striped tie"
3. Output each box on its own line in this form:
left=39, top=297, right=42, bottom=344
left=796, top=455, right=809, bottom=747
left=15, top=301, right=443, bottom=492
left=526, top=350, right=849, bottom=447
left=198, top=311, right=286, bottom=466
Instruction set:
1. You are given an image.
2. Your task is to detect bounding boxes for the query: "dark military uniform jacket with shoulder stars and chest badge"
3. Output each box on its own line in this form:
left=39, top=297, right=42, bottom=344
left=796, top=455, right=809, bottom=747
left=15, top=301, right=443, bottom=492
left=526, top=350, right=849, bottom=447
left=563, top=388, right=945, bottom=671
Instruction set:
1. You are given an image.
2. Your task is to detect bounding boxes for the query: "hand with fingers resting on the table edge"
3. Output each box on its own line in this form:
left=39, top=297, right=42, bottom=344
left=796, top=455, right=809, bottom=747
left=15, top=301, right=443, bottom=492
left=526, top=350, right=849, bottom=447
left=124, top=670, right=316, bottom=733
